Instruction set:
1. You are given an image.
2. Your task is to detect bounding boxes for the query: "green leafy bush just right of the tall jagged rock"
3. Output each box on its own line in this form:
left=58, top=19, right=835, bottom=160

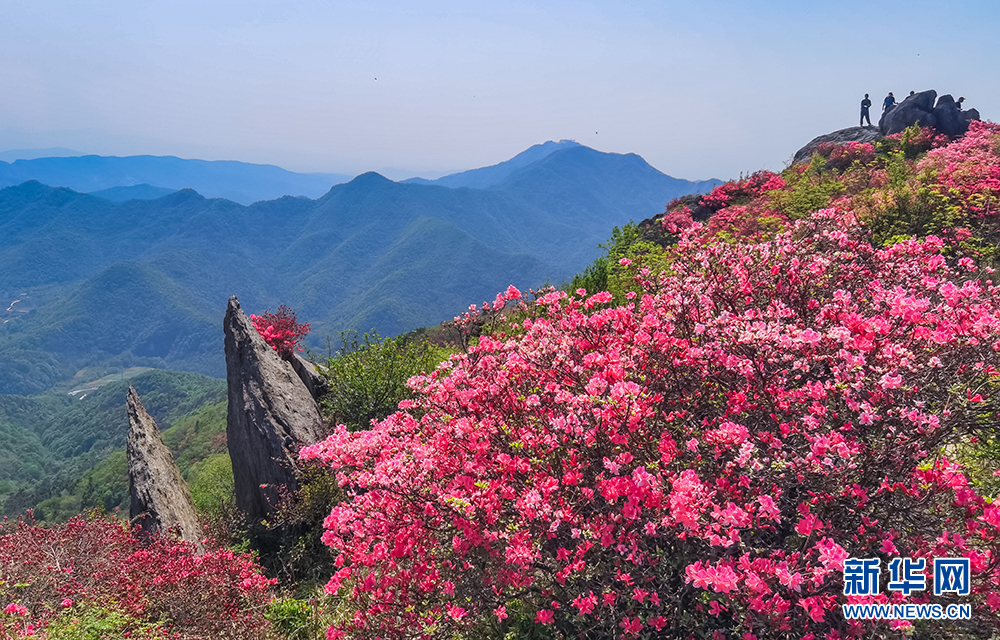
left=322, top=333, right=449, bottom=429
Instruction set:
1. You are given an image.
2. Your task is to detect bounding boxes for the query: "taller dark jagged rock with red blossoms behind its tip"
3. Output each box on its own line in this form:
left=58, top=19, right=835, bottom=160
left=224, top=296, right=323, bottom=521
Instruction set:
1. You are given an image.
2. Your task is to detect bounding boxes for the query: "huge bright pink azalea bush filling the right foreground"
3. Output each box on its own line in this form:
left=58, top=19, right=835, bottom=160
left=302, top=212, right=1000, bottom=639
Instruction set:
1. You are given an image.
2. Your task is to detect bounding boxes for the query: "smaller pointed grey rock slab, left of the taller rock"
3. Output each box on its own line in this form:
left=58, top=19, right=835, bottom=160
left=125, top=387, right=203, bottom=551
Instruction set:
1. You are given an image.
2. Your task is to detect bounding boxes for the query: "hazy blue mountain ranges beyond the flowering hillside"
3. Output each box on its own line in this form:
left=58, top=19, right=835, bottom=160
left=0, top=141, right=717, bottom=393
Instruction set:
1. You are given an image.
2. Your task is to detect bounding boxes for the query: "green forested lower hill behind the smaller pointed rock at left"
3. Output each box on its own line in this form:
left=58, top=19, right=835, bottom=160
left=0, top=370, right=226, bottom=522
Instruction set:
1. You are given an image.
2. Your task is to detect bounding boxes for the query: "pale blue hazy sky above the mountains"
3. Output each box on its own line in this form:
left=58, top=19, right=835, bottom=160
left=0, top=0, right=1000, bottom=179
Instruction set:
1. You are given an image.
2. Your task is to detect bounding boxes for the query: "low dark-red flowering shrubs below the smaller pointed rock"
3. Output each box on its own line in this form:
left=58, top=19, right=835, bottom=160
left=0, top=516, right=272, bottom=638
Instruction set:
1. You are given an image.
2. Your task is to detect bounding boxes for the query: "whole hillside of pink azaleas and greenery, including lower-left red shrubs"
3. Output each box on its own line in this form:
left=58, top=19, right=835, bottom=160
left=0, top=122, right=1000, bottom=640
